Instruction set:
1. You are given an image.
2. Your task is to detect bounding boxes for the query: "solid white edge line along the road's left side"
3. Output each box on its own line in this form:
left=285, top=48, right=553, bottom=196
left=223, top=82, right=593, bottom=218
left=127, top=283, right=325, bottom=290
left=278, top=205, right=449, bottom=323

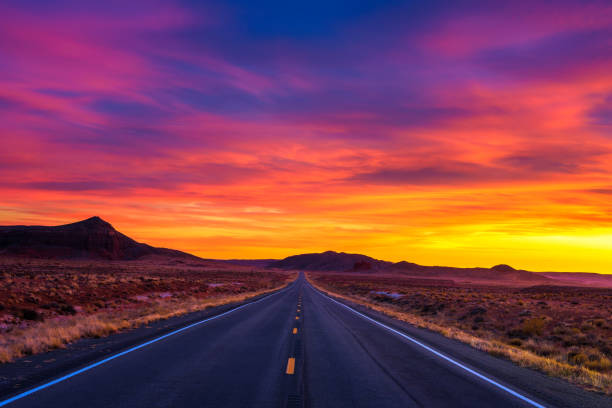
left=0, top=279, right=297, bottom=407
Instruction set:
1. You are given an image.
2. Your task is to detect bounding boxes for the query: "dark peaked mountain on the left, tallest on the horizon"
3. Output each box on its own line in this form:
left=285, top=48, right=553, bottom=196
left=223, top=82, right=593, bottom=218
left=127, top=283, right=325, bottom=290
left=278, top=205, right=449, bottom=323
left=0, top=217, right=199, bottom=260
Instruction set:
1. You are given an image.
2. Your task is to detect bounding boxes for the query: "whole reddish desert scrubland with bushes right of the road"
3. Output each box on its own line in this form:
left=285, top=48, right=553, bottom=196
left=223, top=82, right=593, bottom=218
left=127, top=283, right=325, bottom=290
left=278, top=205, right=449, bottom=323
left=308, top=273, right=612, bottom=394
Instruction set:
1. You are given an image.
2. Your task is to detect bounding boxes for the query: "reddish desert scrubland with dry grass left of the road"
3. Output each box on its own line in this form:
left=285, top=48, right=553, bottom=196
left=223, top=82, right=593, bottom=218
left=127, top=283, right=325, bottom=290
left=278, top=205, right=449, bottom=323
left=0, top=258, right=294, bottom=362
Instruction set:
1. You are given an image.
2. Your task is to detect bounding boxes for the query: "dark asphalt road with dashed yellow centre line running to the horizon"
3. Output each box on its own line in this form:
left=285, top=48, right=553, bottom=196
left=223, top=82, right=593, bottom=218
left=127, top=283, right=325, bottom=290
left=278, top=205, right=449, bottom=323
left=0, top=276, right=611, bottom=408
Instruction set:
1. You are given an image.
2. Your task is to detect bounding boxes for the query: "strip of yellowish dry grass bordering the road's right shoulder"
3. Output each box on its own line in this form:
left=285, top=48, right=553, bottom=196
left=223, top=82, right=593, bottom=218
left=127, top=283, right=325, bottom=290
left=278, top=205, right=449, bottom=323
left=308, top=274, right=612, bottom=395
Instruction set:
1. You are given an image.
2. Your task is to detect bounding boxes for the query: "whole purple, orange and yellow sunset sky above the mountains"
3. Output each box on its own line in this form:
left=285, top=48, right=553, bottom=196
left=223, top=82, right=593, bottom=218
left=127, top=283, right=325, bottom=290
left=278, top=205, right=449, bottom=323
left=0, top=0, right=612, bottom=273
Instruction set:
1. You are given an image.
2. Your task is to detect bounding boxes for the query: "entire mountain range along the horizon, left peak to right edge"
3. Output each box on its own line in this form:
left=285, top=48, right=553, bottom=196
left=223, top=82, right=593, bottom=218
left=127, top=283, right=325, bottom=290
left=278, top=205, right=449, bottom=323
left=0, top=217, right=612, bottom=287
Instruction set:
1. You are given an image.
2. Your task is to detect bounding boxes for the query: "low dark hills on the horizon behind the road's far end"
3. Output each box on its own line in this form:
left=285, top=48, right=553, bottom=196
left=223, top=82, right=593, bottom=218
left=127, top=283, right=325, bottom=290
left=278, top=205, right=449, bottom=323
left=268, top=251, right=554, bottom=284
